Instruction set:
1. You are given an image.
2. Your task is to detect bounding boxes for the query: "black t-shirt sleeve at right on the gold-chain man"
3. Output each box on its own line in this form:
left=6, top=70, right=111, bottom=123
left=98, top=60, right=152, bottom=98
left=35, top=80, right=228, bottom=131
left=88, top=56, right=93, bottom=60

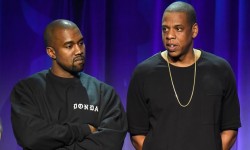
left=221, top=64, right=241, bottom=131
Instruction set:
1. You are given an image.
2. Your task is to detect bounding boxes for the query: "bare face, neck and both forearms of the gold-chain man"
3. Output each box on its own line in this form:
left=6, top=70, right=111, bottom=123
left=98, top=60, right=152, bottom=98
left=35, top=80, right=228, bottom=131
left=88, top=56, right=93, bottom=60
left=131, top=12, right=237, bottom=150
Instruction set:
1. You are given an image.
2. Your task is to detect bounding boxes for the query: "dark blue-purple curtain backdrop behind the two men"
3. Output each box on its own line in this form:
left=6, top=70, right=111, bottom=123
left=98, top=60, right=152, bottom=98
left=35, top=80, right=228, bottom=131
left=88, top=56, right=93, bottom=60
left=0, top=0, right=250, bottom=150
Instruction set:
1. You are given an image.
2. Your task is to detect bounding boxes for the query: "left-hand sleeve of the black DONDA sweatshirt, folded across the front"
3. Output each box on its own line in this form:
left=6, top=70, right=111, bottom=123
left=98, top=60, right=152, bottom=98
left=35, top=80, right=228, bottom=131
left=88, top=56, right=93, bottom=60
left=11, top=82, right=90, bottom=150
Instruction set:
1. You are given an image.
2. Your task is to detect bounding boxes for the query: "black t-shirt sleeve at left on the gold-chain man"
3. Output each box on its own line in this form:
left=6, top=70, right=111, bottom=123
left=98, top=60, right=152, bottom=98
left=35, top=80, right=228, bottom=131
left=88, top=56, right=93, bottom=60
left=127, top=68, right=149, bottom=135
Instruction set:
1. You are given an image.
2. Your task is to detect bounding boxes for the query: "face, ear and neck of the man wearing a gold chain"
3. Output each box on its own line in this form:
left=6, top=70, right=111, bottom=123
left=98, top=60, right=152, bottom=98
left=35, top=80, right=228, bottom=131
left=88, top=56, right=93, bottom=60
left=162, top=12, right=198, bottom=67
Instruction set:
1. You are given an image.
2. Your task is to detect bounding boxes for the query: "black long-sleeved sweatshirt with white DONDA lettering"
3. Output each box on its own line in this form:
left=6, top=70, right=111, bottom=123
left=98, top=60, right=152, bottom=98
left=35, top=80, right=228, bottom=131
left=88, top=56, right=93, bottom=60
left=11, top=70, right=127, bottom=150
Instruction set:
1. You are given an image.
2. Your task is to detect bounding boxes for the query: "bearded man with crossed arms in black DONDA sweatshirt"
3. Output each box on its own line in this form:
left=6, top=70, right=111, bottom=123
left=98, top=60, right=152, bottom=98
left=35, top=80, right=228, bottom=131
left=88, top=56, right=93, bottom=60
left=11, top=19, right=127, bottom=150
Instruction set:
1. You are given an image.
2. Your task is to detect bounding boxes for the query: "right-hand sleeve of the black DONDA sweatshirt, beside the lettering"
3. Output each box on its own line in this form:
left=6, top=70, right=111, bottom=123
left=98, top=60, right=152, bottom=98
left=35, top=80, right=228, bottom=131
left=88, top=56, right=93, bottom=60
left=74, top=86, right=127, bottom=150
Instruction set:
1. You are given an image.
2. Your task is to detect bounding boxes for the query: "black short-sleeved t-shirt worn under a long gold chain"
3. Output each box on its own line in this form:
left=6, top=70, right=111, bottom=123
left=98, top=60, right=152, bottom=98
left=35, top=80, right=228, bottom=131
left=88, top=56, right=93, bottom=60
left=127, top=51, right=240, bottom=150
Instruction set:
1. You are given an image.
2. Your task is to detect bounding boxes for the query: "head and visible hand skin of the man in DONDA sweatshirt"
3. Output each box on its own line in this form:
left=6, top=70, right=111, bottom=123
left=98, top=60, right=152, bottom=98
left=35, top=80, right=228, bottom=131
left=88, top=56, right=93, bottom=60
left=46, top=20, right=96, bottom=133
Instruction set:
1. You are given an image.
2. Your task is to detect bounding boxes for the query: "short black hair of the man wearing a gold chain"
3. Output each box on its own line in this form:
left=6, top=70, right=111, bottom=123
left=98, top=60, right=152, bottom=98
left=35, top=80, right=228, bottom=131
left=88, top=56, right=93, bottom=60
left=164, top=1, right=196, bottom=25
